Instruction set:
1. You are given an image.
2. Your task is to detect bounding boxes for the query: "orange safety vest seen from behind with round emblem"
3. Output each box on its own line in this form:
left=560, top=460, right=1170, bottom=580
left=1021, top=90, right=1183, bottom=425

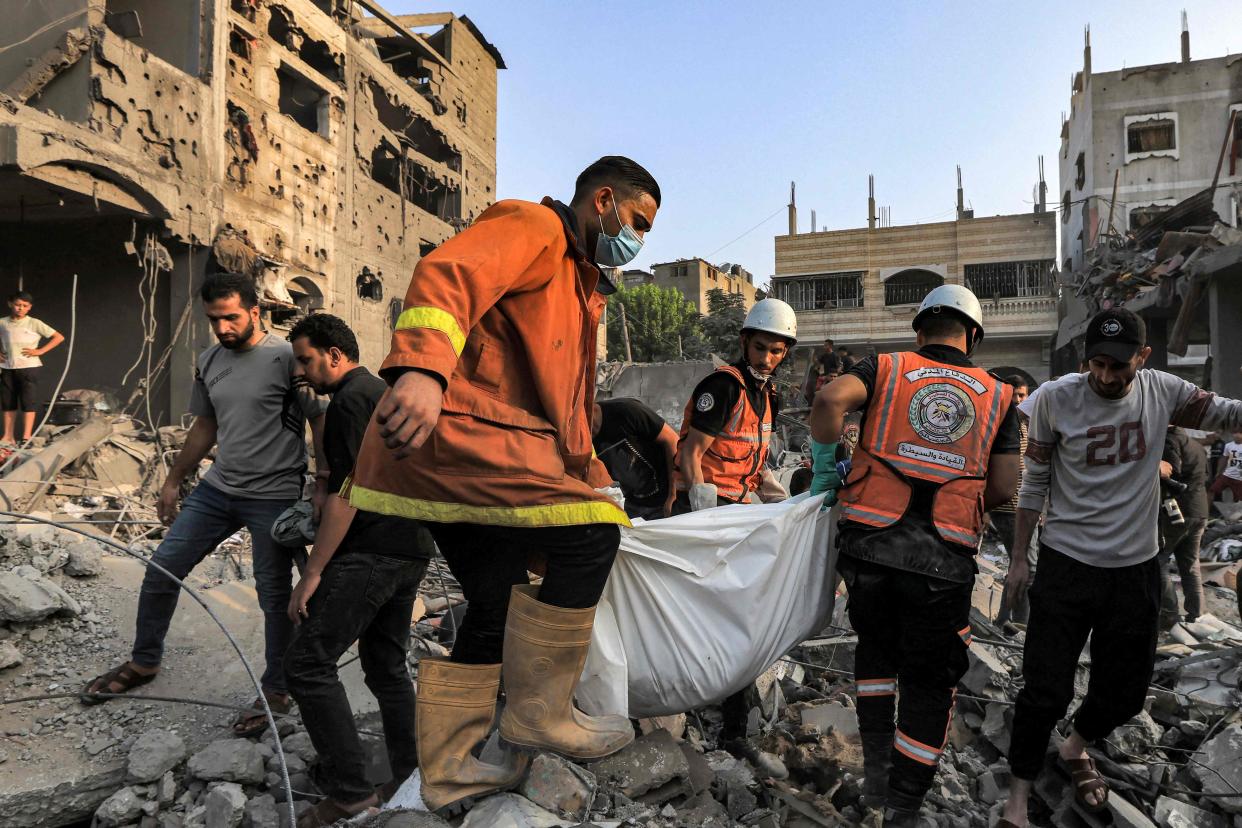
left=840, top=351, right=1013, bottom=547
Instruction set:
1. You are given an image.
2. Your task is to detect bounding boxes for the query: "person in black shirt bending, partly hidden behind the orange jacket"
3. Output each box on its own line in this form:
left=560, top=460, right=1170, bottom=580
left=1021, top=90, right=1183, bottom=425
left=591, top=397, right=677, bottom=520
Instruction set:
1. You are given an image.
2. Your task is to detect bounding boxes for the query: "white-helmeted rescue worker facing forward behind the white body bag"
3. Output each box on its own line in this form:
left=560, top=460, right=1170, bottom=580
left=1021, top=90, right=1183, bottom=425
left=673, top=299, right=797, bottom=515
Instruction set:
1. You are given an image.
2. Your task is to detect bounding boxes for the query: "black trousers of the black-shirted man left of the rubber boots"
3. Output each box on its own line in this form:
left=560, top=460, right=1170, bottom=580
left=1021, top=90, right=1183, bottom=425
left=284, top=551, right=427, bottom=804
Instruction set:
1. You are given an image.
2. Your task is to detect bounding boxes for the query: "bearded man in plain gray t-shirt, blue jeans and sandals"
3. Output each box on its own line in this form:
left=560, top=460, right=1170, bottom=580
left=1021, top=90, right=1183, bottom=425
left=82, top=273, right=328, bottom=736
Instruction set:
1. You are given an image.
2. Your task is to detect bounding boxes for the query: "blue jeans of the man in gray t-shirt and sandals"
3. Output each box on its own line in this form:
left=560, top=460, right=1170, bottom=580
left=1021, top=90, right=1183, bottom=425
left=133, top=483, right=306, bottom=694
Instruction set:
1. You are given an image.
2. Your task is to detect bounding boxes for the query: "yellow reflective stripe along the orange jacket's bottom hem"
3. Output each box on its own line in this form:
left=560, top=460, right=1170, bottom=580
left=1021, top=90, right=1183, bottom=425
left=349, top=483, right=630, bottom=526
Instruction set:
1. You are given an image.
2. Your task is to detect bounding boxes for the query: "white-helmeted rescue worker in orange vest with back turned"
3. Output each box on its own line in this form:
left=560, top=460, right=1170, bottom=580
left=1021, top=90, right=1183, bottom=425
left=811, top=284, right=1020, bottom=826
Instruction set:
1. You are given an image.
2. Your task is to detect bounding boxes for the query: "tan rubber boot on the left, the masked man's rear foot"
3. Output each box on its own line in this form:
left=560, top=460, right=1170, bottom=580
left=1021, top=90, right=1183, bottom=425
left=414, top=658, right=529, bottom=813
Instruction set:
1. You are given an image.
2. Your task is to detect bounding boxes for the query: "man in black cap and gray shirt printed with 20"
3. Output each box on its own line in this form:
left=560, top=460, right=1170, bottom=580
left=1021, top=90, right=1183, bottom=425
left=999, top=308, right=1242, bottom=828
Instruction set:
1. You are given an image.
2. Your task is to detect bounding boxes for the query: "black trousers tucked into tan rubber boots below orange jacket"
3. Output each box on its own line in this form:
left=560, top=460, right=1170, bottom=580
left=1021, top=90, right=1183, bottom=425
left=427, top=524, right=621, bottom=664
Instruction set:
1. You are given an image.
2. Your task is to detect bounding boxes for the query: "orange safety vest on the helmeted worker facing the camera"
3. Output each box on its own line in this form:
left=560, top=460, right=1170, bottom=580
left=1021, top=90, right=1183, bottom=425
left=677, top=365, right=776, bottom=502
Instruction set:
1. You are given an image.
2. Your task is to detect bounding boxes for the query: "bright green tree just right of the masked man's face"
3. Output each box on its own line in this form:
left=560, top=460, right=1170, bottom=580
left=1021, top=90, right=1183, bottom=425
left=609, top=284, right=703, bottom=362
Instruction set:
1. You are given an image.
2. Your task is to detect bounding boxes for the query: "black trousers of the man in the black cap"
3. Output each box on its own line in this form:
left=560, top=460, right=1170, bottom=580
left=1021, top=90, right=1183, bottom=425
left=1010, top=546, right=1160, bottom=780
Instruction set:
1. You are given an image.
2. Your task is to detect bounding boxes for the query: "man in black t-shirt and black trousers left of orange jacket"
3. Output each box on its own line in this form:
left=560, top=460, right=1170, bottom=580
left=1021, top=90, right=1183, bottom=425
left=284, top=314, right=435, bottom=824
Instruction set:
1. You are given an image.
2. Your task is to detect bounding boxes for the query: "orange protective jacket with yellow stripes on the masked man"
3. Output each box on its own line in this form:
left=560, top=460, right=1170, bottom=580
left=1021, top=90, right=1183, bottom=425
left=342, top=199, right=628, bottom=526
